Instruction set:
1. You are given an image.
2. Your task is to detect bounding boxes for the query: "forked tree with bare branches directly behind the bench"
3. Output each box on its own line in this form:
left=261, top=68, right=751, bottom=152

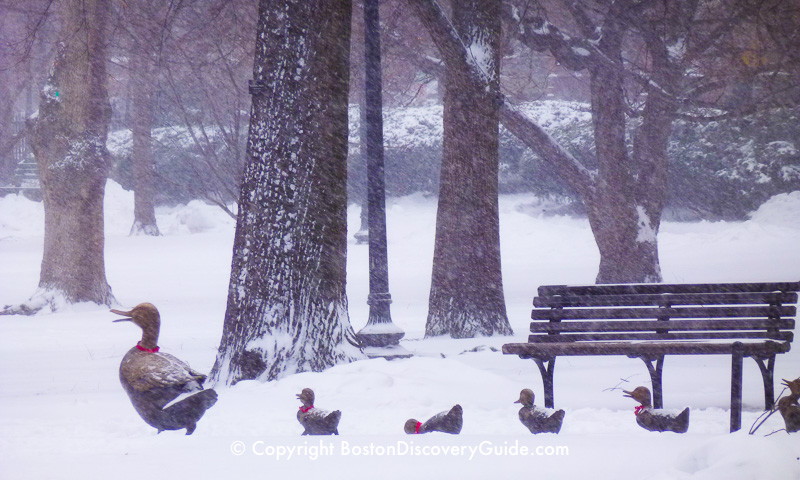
left=504, top=2, right=676, bottom=283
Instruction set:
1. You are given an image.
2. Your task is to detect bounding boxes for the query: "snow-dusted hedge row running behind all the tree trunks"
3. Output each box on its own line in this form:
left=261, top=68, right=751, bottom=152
left=108, top=101, right=800, bottom=220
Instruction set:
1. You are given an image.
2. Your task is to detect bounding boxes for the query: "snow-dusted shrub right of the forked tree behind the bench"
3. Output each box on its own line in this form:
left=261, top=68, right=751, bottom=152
left=669, top=108, right=800, bottom=219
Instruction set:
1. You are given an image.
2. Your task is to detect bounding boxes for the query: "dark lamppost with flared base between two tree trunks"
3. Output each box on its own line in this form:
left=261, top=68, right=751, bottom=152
left=356, top=0, right=412, bottom=359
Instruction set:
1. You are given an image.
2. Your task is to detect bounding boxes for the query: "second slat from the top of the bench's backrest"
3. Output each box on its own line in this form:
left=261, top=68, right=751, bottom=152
left=533, top=292, right=797, bottom=308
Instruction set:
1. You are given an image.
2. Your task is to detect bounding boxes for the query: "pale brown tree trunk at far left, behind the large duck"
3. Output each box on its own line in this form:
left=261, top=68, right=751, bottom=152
left=24, top=0, right=113, bottom=310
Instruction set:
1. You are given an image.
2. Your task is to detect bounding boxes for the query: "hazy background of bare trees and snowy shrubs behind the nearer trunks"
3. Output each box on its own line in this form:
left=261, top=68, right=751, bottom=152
left=0, top=0, right=800, bottom=219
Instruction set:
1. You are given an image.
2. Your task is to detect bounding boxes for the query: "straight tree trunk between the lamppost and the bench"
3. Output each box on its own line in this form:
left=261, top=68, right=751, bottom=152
left=422, top=0, right=512, bottom=338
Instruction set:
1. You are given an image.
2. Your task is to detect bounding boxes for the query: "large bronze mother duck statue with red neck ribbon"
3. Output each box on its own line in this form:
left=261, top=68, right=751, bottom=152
left=111, top=303, right=217, bottom=435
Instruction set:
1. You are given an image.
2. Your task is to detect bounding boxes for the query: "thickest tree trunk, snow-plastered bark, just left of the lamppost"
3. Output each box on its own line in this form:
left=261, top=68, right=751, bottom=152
left=212, top=0, right=361, bottom=384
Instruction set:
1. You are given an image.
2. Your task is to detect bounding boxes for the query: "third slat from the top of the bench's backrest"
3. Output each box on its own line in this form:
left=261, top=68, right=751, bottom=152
left=531, top=306, right=797, bottom=320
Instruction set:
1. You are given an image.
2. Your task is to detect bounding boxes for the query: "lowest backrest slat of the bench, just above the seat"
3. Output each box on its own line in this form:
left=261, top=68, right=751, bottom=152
left=531, top=319, right=794, bottom=333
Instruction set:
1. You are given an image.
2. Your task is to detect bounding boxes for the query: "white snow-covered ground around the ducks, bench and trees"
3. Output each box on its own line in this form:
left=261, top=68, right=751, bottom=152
left=0, top=182, right=800, bottom=480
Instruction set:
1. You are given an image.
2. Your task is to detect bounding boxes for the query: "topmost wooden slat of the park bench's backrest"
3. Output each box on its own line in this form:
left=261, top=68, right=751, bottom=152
left=538, top=282, right=800, bottom=297
